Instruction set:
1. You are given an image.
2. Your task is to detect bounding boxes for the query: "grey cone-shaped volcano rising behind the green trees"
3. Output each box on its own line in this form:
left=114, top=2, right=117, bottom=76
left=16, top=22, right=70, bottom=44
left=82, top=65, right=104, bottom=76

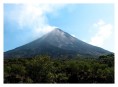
left=4, top=28, right=111, bottom=58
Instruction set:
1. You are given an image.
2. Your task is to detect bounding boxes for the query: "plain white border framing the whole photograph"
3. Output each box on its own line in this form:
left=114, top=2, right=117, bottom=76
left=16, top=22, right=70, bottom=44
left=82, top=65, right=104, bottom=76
left=0, top=0, right=118, bottom=87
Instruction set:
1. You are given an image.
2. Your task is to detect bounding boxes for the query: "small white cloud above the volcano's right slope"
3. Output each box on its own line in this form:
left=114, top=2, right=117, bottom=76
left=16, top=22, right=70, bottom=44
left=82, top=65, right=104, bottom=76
left=90, top=20, right=113, bottom=47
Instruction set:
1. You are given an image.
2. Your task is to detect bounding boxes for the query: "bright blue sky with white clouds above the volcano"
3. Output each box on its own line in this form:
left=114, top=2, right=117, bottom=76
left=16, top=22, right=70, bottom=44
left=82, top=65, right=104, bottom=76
left=4, top=4, right=114, bottom=52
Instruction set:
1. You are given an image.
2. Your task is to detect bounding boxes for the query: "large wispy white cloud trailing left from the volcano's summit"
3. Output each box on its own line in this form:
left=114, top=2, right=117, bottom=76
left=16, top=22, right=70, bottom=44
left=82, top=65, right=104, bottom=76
left=7, top=4, right=65, bottom=36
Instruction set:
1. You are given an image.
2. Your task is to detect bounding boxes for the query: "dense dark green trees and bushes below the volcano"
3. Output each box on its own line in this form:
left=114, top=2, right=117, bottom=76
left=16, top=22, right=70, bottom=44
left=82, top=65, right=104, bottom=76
left=4, top=54, right=114, bottom=83
